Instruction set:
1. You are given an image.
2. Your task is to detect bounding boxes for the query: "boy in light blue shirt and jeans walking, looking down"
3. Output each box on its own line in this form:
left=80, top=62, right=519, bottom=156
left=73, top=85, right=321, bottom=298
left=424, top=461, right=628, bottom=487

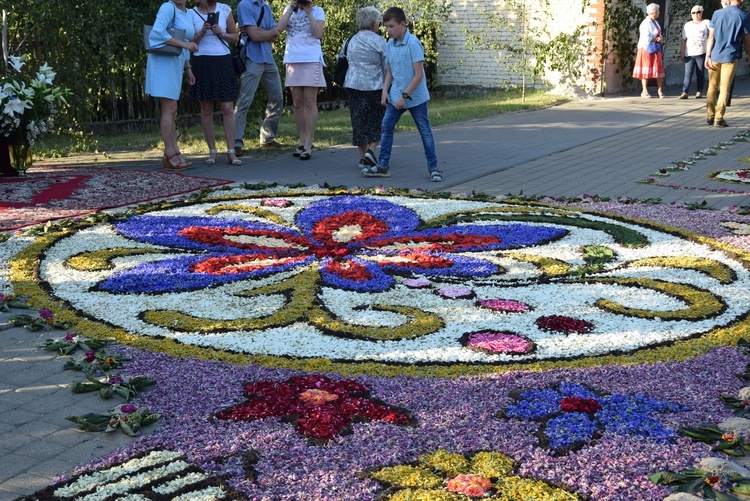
left=362, top=7, right=443, bottom=182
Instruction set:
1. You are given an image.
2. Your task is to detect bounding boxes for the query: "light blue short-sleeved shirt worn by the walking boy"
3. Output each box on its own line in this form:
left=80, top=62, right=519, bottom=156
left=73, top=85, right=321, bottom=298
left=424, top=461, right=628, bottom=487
left=385, top=30, right=430, bottom=108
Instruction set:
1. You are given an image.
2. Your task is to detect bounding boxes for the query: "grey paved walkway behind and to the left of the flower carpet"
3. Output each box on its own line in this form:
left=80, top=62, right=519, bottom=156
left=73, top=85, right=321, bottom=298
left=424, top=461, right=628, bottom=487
left=0, top=80, right=750, bottom=500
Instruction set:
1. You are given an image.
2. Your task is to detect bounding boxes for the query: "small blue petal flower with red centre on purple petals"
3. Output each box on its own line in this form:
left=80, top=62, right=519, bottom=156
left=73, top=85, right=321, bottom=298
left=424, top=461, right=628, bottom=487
left=500, top=383, right=686, bottom=453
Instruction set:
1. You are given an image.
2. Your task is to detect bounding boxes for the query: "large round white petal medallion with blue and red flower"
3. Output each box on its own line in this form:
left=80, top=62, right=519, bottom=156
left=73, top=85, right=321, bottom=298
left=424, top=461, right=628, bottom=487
left=8, top=189, right=750, bottom=373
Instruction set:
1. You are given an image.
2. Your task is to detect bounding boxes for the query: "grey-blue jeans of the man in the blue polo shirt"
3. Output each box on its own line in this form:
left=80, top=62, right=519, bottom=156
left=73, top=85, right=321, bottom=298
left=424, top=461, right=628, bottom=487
left=234, top=58, right=284, bottom=148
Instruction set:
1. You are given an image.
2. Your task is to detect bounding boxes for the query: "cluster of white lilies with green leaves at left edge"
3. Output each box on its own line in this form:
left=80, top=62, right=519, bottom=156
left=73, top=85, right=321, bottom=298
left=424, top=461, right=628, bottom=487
left=0, top=55, right=67, bottom=144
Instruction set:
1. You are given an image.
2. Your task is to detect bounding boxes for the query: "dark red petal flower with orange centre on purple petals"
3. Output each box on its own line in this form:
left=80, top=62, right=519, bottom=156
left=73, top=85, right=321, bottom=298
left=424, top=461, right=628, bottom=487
left=216, top=375, right=412, bottom=441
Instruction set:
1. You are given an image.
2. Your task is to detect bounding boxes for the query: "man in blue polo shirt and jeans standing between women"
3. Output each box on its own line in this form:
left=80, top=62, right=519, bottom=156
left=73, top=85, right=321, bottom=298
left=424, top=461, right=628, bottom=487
left=234, top=0, right=284, bottom=156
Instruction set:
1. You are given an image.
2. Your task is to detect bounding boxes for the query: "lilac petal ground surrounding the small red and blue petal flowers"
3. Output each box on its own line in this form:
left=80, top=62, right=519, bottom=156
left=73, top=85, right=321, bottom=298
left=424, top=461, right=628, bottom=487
left=60, top=347, right=749, bottom=501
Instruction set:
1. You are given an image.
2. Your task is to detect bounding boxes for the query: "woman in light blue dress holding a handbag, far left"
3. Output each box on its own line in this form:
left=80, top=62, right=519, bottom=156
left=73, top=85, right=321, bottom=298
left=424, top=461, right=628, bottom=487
left=146, top=0, right=198, bottom=170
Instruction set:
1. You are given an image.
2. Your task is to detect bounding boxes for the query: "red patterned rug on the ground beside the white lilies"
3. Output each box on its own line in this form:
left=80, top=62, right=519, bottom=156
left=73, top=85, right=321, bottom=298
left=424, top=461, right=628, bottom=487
left=0, top=167, right=230, bottom=231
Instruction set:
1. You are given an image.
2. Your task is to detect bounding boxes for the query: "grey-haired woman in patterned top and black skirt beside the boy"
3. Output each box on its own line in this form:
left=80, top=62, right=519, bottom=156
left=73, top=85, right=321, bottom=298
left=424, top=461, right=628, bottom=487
left=341, top=7, right=386, bottom=170
